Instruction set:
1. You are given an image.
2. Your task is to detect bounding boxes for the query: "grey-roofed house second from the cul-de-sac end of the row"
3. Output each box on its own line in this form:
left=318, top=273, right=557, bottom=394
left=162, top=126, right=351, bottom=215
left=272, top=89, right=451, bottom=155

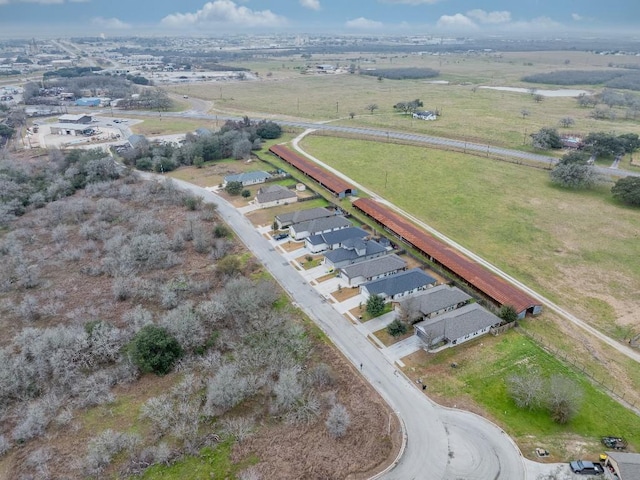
left=400, top=284, right=472, bottom=320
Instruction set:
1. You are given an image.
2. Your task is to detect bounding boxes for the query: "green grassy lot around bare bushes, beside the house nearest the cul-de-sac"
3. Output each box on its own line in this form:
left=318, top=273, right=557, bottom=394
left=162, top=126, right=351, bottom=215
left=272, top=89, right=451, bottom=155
left=407, top=330, right=640, bottom=461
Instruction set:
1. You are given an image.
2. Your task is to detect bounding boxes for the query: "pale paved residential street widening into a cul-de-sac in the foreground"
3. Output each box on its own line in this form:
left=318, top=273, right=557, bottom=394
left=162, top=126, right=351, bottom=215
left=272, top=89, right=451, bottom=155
left=139, top=174, right=551, bottom=480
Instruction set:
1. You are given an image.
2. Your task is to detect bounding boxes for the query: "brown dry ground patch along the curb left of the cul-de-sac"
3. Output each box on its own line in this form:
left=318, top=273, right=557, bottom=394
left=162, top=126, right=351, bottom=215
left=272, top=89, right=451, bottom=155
left=234, top=347, right=401, bottom=480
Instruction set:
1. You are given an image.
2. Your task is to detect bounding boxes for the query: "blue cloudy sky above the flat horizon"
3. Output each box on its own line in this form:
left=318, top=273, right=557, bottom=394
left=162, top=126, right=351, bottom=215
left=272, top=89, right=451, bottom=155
left=0, top=0, right=640, bottom=38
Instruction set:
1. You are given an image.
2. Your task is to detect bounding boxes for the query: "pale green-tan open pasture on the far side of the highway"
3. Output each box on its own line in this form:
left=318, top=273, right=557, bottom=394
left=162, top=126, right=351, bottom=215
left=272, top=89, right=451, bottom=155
left=172, top=52, right=640, bottom=150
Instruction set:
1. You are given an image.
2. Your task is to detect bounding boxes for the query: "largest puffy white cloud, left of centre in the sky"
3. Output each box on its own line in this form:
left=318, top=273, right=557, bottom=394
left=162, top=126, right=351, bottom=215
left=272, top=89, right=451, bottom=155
left=161, top=0, right=287, bottom=28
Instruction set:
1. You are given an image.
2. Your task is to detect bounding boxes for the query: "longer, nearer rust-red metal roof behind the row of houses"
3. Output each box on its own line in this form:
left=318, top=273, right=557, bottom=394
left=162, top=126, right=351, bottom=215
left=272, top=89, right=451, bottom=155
left=353, top=198, right=540, bottom=313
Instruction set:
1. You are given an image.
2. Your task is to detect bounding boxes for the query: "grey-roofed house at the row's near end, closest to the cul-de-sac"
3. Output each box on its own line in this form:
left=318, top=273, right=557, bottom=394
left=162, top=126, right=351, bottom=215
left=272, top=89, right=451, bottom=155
left=413, top=303, right=502, bottom=350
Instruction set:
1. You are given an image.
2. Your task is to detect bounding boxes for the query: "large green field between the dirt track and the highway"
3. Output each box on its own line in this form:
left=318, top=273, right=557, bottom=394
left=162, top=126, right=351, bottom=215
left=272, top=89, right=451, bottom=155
left=302, top=136, right=640, bottom=334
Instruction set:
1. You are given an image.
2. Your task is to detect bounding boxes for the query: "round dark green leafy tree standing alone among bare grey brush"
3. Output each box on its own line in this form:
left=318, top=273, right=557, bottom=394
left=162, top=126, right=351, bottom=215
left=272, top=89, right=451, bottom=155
left=129, top=325, right=183, bottom=375
